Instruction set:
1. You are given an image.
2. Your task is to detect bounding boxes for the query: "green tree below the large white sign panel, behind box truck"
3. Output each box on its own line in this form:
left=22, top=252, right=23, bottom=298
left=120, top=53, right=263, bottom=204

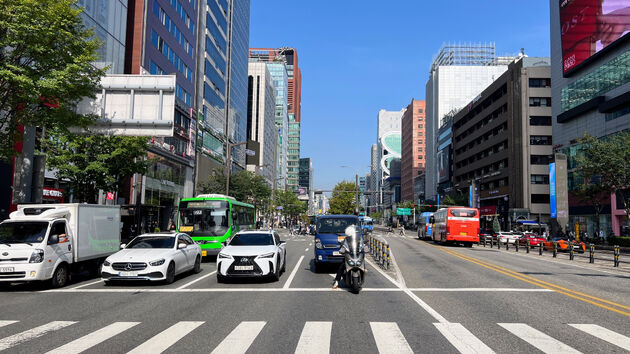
left=43, top=130, right=152, bottom=203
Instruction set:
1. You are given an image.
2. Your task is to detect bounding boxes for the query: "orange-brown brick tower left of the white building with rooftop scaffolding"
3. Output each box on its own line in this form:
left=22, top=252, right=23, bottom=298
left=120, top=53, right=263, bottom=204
left=401, top=99, right=426, bottom=200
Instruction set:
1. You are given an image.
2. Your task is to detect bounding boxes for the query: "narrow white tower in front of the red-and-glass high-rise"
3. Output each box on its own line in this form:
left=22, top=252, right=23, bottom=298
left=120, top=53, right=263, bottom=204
left=246, top=62, right=278, bottom=186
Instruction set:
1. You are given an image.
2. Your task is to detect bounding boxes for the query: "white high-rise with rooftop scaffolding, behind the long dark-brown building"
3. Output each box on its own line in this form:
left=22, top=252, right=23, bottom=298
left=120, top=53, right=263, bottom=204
left=425, top=44, right=513, bottom=200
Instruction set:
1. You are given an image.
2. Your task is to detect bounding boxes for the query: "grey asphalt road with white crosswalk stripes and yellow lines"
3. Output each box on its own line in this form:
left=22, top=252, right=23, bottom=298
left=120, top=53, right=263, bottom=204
left=0, top=228, right=630, bottom=354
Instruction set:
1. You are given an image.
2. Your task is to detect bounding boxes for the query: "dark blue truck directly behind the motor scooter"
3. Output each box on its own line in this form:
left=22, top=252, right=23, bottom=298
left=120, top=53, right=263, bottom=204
left=314, top=215, right=362, bottom=271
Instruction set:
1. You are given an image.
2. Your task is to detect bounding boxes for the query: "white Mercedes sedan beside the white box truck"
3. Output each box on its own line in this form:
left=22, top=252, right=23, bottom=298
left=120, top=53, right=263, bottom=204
left=101, top=233, right=201, bottom=284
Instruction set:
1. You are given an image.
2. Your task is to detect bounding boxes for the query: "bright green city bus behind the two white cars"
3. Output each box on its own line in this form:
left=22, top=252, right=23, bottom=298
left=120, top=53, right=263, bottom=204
left=177, top=194, right=256, bottom=256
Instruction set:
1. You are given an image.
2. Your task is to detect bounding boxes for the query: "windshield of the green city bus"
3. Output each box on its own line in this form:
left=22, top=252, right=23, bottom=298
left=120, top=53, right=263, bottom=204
left=179, top=201, right=229, bottom=236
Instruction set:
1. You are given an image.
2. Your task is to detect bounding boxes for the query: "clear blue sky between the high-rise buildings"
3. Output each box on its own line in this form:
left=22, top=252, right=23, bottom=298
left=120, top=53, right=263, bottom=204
left=250, top=0, right=549, bottom=189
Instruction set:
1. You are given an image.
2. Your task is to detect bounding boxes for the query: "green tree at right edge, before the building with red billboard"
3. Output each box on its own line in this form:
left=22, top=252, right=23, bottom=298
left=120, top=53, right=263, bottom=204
left=576, top=132, right=630, bottom=227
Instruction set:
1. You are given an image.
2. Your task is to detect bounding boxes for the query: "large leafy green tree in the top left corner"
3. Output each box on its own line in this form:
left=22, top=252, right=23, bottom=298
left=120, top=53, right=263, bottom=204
left=0, top=0, right=105, bottom=160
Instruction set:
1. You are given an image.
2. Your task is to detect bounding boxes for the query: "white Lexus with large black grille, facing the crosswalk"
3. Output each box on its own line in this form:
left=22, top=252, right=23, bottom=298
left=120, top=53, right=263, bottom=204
left=217, top=230, right=287, bottom=282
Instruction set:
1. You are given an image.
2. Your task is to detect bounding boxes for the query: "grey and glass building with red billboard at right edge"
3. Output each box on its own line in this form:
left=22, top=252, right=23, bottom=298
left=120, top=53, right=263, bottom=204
left=550, top=0, right=630, bottom=236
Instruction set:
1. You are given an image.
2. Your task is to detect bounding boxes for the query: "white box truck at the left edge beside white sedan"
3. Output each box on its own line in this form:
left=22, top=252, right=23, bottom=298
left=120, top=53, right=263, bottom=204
left=0, top=204, right=120, bottom=287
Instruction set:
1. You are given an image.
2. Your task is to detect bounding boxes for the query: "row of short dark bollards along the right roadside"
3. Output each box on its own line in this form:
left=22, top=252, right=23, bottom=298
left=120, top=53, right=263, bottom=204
left=479, top=237, right=630, bottom=268
